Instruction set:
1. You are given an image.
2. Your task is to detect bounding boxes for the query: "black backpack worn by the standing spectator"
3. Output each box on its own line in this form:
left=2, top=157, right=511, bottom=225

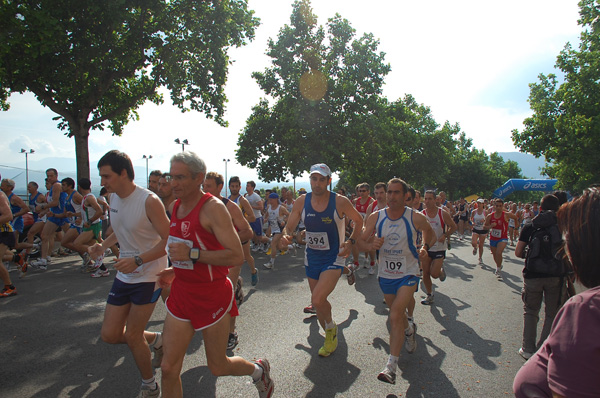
left=525, top=224, right=567, bottom=276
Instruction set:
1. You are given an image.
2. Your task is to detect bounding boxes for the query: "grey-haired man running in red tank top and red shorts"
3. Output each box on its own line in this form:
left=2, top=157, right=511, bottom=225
left=159, top=152, right=274, bottom=398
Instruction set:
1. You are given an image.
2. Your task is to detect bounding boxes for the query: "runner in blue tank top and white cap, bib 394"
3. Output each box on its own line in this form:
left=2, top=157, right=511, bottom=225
left=279, top=163, right=363, bottom=357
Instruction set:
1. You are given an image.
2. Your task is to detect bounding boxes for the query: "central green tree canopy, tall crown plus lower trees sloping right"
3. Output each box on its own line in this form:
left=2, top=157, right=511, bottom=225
left=236, top=0, right=521, bottom=196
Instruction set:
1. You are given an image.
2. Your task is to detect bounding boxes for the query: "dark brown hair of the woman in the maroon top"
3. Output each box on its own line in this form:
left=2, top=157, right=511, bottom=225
left=558, top=188, right=600, bottom=288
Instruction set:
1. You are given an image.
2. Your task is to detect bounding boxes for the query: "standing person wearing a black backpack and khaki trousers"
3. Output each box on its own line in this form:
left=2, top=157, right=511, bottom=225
left=515, top=194, right=567, bottom=360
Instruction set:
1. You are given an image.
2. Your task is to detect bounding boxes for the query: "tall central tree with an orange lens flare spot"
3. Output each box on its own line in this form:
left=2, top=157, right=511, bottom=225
left=236, top=0, right=390, bottom=181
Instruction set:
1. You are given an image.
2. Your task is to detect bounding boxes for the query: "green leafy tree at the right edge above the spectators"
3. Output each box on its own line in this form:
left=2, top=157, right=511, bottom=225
left=513, top=0, right=600, bottom=190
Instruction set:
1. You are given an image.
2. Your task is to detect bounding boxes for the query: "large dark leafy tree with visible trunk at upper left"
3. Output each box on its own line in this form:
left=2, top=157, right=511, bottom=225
left=0, top=0, right=258, bottom=177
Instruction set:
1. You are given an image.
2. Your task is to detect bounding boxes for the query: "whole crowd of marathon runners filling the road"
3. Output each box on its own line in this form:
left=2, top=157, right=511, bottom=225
left=0, top=151, right=572, bottom=398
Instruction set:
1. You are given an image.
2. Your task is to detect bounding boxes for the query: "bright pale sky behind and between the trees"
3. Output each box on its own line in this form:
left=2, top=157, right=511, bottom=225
left=0, top=0, right=580, bottom=185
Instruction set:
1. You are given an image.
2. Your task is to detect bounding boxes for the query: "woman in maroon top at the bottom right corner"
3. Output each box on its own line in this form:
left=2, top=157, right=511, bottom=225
left=513, top=188, right=600, bottom=398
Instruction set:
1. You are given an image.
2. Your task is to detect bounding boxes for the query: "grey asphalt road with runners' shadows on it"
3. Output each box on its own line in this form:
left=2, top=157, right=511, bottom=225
left=0, top=236, right=541, bottom=398
